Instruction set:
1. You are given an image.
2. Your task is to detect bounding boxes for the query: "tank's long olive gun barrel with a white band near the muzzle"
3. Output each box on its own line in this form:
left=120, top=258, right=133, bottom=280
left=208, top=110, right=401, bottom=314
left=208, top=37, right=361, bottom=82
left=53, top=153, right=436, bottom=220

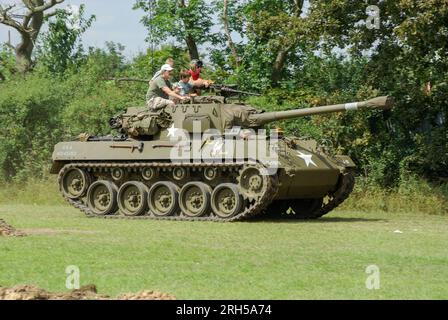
left=249, top=96, right=393, bottom=127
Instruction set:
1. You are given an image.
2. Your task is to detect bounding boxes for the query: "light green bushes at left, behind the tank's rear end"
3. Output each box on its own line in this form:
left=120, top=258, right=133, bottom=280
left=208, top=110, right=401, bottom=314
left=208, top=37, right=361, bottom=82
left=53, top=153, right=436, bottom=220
left=0, top=44, right=146, bottom=181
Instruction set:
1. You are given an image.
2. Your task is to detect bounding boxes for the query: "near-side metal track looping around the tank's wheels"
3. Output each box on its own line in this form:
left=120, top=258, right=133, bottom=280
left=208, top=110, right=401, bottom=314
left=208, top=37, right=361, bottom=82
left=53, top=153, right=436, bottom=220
left=58, top=162, right=279, bottom=222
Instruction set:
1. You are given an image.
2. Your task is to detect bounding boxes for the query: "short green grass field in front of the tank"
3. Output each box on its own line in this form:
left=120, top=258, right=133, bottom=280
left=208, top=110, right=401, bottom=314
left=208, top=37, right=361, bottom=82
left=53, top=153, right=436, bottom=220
left=0, top=205, right=448, bottom=299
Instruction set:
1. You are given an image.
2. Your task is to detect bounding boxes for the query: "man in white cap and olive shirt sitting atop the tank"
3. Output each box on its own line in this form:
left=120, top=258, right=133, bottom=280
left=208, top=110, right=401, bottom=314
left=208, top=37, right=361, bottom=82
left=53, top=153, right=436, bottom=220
left=146, top=64, right=188, bottom=111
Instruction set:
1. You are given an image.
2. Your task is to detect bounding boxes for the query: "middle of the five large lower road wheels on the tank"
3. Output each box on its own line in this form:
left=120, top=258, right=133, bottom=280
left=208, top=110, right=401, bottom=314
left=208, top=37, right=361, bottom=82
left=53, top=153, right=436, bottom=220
left=148, top=181, right=179, bottom=217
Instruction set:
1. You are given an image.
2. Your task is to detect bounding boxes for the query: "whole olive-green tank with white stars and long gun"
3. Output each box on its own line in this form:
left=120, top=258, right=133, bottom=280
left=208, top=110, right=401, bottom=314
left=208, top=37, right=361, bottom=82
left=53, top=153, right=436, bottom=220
left=51, top=96, right=392, bottom=222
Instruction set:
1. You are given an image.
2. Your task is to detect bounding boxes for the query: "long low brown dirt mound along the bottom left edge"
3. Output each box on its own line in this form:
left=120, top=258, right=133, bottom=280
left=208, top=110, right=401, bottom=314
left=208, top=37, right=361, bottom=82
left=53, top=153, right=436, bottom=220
left=0, top=285, right=176, bottom=300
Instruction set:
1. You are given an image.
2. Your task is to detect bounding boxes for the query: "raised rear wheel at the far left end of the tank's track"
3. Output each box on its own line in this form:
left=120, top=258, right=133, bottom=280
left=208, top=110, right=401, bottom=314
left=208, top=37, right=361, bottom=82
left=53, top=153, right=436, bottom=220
left=61, top=168, right=91, bottom=199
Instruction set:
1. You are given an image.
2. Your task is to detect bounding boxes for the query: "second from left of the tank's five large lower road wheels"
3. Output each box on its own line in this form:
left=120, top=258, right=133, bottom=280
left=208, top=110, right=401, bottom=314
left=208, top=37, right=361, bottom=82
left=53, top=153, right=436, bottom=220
left=118, top=181, right=149, bottom=216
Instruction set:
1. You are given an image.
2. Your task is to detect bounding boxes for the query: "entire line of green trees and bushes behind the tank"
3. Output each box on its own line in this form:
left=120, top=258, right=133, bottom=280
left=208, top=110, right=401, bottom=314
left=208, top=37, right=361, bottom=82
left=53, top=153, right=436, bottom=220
left=0, top=0, right=448, bottom=191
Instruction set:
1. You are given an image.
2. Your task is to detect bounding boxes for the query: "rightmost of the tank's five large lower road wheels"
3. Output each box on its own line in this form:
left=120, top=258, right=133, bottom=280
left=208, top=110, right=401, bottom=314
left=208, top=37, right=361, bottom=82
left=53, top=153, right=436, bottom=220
left=211, top=183, right=243, bottom=219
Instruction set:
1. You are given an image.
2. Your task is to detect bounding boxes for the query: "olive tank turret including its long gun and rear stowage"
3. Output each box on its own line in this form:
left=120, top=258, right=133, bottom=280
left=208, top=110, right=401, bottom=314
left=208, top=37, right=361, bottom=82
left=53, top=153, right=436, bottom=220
left=110, top=96, right=393, bottom=134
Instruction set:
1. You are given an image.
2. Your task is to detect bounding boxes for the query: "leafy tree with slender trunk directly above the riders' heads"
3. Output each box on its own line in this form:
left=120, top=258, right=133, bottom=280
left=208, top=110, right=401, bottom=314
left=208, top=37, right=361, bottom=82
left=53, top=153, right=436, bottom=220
left=134, top=0, right=213, bottom=59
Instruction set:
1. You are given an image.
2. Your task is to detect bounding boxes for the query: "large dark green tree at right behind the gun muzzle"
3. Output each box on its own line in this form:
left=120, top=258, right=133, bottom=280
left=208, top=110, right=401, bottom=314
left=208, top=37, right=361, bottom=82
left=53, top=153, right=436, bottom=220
left=284, top=0, right=448, bottom=185
